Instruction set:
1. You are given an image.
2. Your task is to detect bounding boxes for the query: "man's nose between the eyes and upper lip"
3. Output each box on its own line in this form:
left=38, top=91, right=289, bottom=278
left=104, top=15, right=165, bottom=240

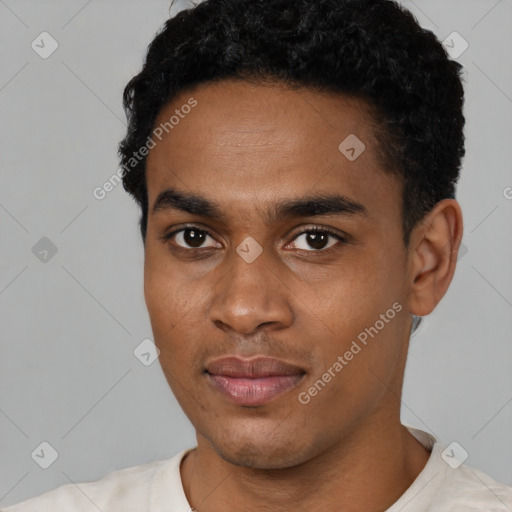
left=209, top=245, right=294, bottom=335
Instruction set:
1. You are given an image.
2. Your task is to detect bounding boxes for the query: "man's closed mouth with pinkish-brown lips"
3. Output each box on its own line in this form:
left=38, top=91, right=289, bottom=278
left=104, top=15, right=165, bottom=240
left=205, top=356, right=306, bottom=406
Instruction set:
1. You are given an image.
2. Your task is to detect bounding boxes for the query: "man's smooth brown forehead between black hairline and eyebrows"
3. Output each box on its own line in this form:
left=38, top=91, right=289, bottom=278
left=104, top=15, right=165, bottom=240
left=146, top=80, right=400, bottom=222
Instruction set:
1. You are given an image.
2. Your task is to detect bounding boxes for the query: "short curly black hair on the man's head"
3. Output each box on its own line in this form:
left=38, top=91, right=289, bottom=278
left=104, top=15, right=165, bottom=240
left=119, top=0, right=465, bottom=246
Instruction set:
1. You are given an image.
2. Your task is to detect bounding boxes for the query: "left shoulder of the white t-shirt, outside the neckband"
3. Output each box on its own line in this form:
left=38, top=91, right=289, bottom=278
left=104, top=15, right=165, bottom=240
left=0, top=452, right=186, bottom=512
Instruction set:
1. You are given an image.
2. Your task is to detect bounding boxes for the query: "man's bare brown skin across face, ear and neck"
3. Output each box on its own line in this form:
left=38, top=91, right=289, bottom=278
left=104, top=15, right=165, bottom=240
left=144, top=80, right=462, bottom=512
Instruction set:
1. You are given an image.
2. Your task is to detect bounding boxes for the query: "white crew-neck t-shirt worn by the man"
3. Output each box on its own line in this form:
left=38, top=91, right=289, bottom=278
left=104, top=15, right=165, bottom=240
left=0, top=427, right=512, bottom=512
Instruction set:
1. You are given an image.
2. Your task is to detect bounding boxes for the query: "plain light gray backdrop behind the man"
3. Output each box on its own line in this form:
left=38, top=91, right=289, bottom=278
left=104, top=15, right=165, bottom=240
left=0, top=0, right=512, bottom=506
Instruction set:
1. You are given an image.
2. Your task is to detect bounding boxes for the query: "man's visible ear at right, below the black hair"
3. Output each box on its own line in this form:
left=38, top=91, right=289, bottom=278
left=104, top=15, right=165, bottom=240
left=408, top=199, right=463, bottom=316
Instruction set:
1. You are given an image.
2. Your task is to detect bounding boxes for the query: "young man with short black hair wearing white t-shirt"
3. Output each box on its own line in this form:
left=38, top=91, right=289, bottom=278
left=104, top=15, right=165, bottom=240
left=5, top=0, right=512, bottom=512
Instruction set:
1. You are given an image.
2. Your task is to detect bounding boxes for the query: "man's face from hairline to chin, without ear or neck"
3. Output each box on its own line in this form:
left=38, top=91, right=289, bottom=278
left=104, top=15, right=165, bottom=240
left=144, top=81, right=410, bottom=468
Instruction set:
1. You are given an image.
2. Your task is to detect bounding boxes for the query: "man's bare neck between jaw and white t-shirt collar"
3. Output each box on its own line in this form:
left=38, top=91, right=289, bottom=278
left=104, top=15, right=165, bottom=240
left=181, top=415, right=430, bottom=512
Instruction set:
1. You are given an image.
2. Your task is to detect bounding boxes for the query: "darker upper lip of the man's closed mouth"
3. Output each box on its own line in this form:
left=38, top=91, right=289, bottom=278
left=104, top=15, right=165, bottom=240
left=206, top=356, right=305, bottom=378
